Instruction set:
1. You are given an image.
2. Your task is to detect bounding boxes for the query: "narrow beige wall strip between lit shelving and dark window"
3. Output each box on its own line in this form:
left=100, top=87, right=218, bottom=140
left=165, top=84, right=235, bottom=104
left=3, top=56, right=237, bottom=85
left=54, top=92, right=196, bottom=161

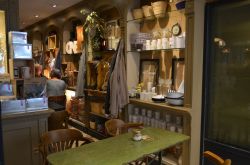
left=190, top=0, right=205, bottom=165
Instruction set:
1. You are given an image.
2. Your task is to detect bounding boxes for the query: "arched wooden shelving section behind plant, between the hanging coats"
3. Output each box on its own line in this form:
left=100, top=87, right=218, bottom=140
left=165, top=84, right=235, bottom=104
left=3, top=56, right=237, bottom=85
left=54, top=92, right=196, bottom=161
left=68, top=5, right=124, bottom=139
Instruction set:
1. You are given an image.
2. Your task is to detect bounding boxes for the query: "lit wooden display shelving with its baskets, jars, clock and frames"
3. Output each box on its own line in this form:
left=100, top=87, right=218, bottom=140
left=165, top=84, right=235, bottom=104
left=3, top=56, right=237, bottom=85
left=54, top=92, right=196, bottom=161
left=126, top=0, right=193, bottom=164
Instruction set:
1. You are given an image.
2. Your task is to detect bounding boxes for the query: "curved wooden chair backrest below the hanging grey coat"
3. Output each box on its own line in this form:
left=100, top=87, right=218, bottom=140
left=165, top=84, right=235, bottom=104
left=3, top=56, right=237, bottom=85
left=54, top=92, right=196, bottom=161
left=105, top=119, right=125, bottom=136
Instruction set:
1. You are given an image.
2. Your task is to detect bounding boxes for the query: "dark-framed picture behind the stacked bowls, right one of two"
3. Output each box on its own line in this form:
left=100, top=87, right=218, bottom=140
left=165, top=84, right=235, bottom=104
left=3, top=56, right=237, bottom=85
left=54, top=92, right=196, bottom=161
left=171, top=58, right=185, bottom=90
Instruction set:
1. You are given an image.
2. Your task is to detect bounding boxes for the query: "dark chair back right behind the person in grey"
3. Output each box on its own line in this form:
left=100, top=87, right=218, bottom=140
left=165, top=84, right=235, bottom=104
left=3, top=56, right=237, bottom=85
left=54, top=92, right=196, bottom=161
left=48, top=95, right=66, bottom=111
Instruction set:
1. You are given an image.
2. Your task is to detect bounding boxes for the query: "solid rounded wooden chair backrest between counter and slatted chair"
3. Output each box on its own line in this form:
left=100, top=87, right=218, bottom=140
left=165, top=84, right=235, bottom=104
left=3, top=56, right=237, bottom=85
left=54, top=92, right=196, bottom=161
left=48, top=111, right=69, bottom=131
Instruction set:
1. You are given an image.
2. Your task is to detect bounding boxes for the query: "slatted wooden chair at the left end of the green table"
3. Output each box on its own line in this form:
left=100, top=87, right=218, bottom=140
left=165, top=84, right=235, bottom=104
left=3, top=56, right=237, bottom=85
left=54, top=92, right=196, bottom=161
left=39, top=129, right=93, bottom=165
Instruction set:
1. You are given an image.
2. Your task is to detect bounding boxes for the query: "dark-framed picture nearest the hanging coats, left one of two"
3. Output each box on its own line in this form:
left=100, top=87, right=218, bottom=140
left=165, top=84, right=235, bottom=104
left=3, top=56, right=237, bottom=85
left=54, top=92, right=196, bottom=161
left=139, top=59, right=159, bottom=89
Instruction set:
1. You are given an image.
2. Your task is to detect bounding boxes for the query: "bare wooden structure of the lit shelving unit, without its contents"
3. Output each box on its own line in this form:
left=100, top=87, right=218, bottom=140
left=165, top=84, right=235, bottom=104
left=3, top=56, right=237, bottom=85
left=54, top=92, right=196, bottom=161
left=126, top=1, right=193, bottom=165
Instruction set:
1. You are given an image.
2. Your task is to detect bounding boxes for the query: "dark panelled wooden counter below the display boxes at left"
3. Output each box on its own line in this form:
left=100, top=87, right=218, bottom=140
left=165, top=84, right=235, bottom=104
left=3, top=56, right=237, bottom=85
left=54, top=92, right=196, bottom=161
left=1, top=109, right=54, bottom=165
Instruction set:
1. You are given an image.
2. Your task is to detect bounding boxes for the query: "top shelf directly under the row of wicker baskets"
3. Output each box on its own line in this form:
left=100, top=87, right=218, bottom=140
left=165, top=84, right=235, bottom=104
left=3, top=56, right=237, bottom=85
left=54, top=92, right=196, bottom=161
left=127, top=9, right=185, bottom=23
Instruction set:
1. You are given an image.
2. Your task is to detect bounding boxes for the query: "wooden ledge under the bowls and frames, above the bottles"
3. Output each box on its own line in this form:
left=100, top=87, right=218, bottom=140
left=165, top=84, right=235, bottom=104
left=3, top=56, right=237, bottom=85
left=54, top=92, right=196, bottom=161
left=129, top=98, right=191, bottom=117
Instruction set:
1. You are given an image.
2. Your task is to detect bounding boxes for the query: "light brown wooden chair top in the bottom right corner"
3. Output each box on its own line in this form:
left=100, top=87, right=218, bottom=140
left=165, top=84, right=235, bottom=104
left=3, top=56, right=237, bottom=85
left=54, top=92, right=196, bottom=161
left=203, top=151, right=231, bottom=165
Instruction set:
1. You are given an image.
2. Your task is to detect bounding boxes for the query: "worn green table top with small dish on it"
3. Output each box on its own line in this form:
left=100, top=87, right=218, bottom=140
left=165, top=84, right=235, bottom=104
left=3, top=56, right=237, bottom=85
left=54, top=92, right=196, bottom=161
left=47, top=128, right=189, bottom=165
